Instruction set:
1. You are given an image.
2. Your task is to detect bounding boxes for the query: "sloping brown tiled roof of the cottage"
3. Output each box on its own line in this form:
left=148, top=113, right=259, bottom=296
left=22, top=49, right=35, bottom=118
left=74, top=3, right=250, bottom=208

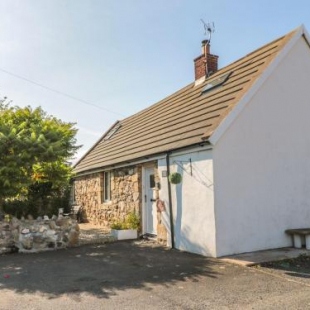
left=74, top=30, right=297, bottom=173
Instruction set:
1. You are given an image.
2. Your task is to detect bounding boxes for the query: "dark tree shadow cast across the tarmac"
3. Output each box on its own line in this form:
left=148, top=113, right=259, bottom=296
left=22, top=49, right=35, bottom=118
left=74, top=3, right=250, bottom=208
left=0, top=241, right=221, bottom=298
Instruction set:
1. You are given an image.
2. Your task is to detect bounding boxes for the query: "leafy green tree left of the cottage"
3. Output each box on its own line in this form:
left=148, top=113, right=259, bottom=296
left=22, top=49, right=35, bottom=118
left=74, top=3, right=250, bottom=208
left=0, top=102, right=79, bottom=204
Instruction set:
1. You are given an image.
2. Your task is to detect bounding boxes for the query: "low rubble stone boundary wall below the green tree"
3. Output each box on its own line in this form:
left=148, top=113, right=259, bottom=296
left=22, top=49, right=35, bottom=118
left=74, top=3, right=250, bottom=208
left=0, top=216, right=80, bottom=254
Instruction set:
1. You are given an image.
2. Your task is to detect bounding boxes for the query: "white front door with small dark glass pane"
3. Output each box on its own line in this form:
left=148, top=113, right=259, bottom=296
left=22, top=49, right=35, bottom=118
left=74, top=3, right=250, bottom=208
left=144, top=167, right=157, bottom=235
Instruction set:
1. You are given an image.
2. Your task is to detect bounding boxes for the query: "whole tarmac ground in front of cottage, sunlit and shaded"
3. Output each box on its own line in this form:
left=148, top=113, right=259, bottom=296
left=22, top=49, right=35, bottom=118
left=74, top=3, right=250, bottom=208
left=0, top=240, right=310, bottom=310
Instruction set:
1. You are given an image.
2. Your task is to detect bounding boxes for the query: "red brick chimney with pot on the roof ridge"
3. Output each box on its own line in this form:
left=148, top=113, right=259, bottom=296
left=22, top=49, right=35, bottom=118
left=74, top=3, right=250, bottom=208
left=194, top=40, right=219, bottom=85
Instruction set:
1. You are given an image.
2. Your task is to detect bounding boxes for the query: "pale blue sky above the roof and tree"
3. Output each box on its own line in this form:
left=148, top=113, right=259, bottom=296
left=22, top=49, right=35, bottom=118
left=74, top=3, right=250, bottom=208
left=0, top=0, right=310, bottom=161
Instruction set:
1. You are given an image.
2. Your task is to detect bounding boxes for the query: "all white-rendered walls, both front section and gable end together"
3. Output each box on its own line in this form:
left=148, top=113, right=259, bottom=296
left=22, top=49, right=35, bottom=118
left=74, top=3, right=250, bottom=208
left=158, top=28, right=310, bottom=257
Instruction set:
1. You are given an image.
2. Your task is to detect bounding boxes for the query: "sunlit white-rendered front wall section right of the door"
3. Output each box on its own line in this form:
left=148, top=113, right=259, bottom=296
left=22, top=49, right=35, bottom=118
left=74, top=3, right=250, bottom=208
left=158, top=150, right=216, bottom=256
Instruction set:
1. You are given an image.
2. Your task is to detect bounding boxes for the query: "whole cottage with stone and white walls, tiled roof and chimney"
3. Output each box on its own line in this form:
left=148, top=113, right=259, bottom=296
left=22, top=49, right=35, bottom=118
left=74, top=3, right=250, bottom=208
left=75, top=26, right=310, bottom=257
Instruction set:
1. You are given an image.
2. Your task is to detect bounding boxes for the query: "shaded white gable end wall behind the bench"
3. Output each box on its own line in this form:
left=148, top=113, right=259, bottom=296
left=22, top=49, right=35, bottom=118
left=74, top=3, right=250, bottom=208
left=211, top=35, right=310, bottom=256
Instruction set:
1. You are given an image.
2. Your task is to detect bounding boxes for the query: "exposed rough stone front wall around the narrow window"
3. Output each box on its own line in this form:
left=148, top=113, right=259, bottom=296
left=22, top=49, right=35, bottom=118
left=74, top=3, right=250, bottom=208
left=74, top=166, right=142, bottom=227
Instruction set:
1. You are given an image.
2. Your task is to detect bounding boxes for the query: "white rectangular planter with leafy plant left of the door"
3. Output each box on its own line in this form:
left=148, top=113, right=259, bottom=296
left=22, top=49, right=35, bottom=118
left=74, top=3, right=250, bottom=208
left=111, top=212, right=140, bottom=240
